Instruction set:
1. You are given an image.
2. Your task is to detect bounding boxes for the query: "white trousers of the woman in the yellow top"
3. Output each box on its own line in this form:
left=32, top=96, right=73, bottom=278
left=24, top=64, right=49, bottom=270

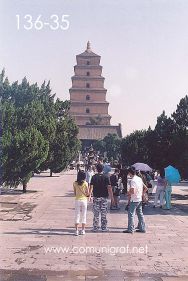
left=75, top=200, right=87, bottom=224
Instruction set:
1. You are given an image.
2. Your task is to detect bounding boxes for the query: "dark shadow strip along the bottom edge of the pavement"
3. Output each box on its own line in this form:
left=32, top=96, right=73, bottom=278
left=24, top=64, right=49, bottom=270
left=0, top=268, right=187, bottom=281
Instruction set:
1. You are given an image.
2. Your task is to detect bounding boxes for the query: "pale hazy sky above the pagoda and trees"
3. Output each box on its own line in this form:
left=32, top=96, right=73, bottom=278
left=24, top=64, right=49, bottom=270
left=0, top=0, right=188, bottom=136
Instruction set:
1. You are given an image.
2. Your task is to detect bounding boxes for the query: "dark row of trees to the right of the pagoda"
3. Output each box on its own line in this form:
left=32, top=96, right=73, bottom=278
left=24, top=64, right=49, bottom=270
left=94, top=96, right=188, bottom=178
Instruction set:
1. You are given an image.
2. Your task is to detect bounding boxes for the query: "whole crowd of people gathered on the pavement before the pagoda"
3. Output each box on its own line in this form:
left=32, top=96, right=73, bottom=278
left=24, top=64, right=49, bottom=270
left=73, top=161, right=172, bottom=236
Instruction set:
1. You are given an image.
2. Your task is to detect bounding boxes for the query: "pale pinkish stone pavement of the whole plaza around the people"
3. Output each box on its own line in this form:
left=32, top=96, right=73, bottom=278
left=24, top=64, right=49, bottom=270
left=0, top=168, right=188, bottom=281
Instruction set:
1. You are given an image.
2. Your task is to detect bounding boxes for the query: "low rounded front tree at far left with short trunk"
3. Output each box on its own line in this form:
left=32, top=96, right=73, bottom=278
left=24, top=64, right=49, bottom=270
left=3, top=128, right=49, bottom=192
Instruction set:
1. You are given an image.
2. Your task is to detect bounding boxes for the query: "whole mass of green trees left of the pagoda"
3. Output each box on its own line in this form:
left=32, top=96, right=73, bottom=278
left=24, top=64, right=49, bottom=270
left=0, top=71, right=79, bottom=191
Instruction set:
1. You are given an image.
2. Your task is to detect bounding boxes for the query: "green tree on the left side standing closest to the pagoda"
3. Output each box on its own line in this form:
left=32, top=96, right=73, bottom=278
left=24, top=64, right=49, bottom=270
left=39, top=99, right=81, bottom=176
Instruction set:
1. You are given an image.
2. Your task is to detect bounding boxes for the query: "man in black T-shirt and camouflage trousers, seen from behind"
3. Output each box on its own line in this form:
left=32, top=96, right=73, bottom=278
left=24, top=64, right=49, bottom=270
left=90, top=164, right=114, bottom=232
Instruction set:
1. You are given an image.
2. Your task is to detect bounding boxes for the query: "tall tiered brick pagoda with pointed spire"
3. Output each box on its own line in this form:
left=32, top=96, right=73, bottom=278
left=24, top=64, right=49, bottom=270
left=69, top=42, right=122, bottom=147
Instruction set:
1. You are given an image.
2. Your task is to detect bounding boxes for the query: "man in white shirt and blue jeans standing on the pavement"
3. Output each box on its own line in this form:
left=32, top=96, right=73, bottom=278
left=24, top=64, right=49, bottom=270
left=123, top=167, right=146, bottom=233
